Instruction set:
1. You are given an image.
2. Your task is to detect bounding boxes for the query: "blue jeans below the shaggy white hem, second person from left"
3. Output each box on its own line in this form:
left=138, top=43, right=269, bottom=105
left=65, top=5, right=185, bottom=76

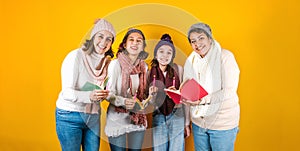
left=108, top=131, right=145, bottom=151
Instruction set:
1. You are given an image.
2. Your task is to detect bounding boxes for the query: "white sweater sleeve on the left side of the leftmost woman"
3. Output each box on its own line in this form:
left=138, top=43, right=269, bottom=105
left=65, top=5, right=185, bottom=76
left=61, top=50, right=91, bottom=103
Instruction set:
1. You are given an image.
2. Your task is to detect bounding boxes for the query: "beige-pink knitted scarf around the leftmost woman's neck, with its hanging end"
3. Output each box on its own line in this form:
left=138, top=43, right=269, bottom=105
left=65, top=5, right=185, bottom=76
left=82, top=51, right=111, bottom=114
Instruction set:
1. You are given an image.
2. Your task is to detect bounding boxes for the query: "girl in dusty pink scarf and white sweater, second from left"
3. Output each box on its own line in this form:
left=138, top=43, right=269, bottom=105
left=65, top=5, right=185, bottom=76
left=105, top=29, right=152, bottom=151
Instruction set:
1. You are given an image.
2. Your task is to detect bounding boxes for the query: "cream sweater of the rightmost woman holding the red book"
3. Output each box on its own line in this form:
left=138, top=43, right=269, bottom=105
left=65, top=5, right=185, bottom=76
left=183, top=49, right=240, bottom=130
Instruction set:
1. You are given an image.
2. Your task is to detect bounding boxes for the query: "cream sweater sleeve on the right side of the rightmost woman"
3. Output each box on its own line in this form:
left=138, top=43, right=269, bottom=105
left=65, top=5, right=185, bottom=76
left=203, top=50, right=240, bottom=104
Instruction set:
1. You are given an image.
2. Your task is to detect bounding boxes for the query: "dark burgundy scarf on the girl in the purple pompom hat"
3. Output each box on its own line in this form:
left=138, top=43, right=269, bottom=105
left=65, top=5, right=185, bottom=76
left=150, top=64, right=180, bottom=116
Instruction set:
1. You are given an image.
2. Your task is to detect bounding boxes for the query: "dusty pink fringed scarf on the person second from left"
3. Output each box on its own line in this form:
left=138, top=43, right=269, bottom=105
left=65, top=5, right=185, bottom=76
left=115, top=52, right=147, bottom=127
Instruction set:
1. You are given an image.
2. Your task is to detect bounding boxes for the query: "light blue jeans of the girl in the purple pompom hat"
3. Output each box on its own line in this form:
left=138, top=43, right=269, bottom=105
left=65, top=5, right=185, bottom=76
left=152, top=108, right=184, bottom=151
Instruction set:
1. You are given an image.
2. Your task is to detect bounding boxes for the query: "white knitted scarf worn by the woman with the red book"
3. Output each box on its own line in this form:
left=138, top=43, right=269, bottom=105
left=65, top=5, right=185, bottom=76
left=191, top=40, right=222, bottom=118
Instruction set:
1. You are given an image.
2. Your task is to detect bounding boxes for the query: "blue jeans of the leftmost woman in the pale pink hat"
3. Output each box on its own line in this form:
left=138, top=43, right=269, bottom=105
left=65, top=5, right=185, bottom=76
left=55, top=108, right=100, bottom=151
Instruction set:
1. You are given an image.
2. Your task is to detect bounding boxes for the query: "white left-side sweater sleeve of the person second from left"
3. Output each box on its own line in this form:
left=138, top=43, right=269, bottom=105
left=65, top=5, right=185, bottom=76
left=107, top=59, right=126, bottom=106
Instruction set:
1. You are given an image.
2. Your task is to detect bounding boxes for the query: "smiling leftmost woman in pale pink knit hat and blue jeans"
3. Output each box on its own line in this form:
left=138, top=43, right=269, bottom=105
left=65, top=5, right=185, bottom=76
left=56, top=19, right=116, bottom=151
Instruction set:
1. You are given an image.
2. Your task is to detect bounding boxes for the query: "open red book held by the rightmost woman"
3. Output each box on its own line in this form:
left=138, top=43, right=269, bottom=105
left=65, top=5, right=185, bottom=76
left=164, top=79, right=208, bottom=104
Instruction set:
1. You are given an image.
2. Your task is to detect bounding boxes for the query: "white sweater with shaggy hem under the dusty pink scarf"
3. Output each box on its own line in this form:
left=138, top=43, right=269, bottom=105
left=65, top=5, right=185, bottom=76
left=104, top=59, right=147, bottom=137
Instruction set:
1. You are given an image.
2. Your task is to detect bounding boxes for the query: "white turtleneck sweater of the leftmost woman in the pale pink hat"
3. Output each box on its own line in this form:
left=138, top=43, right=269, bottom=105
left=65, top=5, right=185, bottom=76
left=56, top=48, right=104, bottom=112
